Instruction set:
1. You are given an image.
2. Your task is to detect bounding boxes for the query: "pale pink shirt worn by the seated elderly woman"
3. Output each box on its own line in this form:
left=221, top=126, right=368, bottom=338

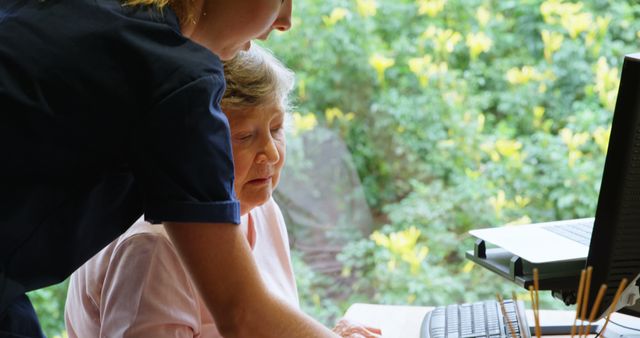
left=65, top=200, right=299, bottom=338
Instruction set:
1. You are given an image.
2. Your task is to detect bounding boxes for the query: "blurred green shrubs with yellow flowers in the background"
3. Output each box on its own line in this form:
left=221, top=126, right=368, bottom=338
left=30, top=0, right=640, bottom=337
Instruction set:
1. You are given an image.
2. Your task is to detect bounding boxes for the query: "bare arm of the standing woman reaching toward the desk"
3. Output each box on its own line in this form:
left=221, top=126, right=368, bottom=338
left=165, top=223, right=337, bottom=338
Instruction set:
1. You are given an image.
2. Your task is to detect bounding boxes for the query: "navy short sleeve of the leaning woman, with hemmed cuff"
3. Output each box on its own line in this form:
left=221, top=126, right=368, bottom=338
left=131, top=72, right=240, bottom=224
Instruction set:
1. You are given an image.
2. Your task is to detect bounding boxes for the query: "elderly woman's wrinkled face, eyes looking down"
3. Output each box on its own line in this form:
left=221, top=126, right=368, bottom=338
left=224, top=103, right=286, bottom=215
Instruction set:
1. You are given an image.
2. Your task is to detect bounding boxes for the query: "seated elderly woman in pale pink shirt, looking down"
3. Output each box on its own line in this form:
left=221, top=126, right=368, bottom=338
left=65, top=46, right=379, bottom=337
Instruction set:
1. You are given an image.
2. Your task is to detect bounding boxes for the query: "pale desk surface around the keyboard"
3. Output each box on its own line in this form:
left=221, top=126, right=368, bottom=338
left=345, top=303, right=640, bottom=338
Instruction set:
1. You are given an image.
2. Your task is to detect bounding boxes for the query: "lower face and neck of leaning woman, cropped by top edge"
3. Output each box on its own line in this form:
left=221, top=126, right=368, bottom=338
left=190, top=0, right=292, bottom=60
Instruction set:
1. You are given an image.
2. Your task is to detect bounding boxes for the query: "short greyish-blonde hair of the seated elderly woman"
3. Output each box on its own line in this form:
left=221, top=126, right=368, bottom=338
left=221, top=44, right=295, bottom=112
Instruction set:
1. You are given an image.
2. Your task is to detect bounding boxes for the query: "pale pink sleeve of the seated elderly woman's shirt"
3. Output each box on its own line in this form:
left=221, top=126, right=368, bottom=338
left=96, top=233, right=202, bottom=338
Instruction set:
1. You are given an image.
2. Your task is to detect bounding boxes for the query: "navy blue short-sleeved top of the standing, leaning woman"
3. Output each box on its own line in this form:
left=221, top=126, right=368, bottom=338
left=0, top=0, right=240, bottom=311
